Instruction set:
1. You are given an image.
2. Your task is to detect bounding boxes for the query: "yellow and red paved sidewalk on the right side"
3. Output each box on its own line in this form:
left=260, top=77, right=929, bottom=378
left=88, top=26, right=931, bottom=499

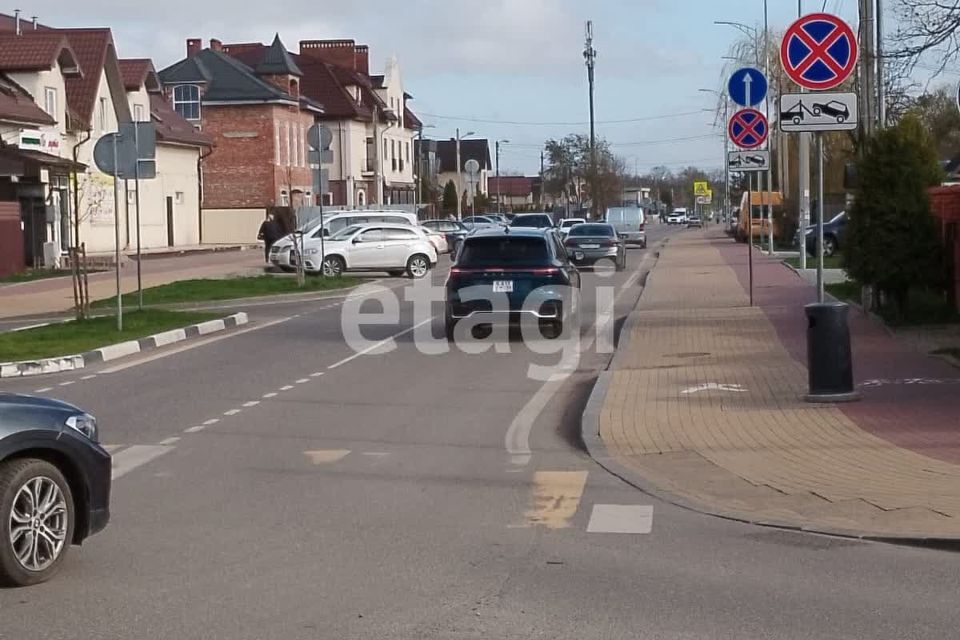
left=586, top=230, right=960, bottom=539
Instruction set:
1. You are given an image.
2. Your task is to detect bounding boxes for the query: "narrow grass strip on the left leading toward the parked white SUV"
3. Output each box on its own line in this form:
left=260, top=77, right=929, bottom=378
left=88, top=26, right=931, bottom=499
left=91, top=276, right=361, bottom=308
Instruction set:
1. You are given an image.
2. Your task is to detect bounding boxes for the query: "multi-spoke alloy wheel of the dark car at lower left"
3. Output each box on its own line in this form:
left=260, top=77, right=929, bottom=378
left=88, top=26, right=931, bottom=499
left=0, top=458, right=74, bottom=587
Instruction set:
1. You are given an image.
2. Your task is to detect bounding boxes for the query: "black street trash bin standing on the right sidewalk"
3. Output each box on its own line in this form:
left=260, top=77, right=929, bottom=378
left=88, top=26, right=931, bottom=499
left=804, top=302, right=860, bottom=402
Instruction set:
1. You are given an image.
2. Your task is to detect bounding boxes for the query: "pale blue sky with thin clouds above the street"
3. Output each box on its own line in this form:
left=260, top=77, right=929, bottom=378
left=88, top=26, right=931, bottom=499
left=18, top=0, right=956, bottom=175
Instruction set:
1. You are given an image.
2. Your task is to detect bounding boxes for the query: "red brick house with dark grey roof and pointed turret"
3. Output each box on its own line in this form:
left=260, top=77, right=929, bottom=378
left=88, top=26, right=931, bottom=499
left=159, top=36, right=323, bottom=242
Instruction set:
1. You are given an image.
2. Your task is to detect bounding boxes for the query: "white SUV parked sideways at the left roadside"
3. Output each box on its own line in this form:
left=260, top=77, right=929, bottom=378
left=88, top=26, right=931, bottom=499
left=293, top=224, right=437, bottom=278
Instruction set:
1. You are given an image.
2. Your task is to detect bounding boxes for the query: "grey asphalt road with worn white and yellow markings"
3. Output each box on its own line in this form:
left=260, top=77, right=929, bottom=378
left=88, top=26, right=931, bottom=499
left=0, top=221, right=960, bottom=640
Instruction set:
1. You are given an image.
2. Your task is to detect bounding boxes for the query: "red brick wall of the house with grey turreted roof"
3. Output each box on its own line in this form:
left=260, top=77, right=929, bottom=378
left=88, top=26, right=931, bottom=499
left=203, top=105, right=313, bottom=209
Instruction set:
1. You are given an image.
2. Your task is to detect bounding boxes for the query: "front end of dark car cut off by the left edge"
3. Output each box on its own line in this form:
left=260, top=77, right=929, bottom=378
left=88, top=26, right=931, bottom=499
left=0, top=393, right=111, bottom=586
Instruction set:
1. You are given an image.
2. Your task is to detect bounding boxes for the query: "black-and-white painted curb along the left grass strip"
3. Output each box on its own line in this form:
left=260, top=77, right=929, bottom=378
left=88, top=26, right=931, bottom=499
left=0, top=312, right=250, bottom=378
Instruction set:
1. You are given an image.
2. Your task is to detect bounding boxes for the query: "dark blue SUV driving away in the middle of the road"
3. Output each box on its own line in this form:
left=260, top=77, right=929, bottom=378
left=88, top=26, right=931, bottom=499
left=444, top=229, right=580, bottom=340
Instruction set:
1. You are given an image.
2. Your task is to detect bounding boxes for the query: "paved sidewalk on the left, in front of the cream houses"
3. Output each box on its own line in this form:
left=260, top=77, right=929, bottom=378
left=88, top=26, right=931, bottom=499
left=0, top=249, right=264, bottom=319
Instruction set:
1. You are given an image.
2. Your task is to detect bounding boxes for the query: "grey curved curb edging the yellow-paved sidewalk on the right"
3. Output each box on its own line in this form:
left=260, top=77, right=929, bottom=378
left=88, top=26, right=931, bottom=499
left=580, top=240, right=960, bottom=550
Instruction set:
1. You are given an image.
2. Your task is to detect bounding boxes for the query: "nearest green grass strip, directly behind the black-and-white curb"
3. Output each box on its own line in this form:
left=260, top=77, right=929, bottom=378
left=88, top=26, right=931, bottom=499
left=0, top=309, right=223, bottom=362
